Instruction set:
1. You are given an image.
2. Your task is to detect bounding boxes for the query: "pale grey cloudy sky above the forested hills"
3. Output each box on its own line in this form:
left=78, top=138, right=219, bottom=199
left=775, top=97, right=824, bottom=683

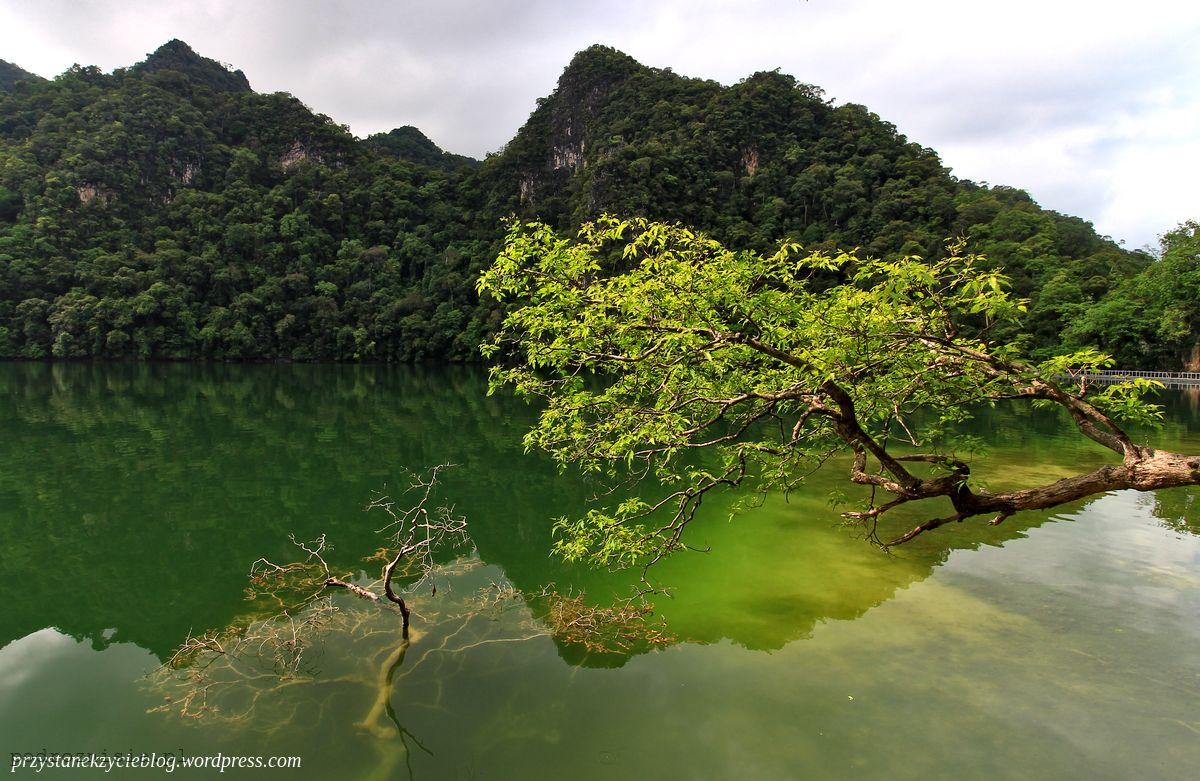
left=0, top=0, right=1200, bottom=247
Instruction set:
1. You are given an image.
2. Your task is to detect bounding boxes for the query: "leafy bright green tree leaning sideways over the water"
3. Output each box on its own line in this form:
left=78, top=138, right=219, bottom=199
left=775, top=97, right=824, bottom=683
left=479, top=217, right=1200, bottom=565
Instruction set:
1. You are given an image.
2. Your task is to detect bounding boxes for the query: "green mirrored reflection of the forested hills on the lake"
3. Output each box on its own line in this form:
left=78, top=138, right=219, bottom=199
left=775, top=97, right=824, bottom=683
left=0, top=364, right=1200, bottom=663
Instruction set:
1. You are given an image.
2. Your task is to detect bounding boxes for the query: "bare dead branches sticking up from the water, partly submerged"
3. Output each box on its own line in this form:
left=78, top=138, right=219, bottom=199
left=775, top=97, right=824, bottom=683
left=150, top=464, right=673, bottom=757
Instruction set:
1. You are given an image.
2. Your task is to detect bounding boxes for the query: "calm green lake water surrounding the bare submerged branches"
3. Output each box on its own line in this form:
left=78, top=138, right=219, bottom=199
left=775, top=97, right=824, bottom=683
left=0, top=364, right=1200, bottom=780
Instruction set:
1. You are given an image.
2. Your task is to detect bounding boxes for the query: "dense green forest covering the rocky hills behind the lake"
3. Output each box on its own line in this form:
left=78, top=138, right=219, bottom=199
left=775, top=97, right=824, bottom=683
left=0, top=41, right=1200, bottom=368
